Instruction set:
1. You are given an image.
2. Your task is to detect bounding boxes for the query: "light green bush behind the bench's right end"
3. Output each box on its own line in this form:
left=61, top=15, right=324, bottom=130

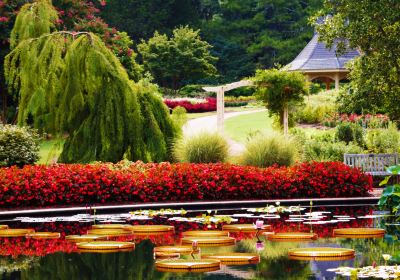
left=366, top=124, right=400, bottom=153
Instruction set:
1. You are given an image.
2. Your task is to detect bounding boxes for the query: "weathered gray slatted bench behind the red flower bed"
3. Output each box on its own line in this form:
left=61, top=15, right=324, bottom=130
left=344, top=154, right=399, bottom=176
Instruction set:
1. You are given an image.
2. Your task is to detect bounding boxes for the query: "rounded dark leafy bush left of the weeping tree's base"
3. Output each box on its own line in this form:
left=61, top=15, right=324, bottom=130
left=0, top=125, right=40, bottom=166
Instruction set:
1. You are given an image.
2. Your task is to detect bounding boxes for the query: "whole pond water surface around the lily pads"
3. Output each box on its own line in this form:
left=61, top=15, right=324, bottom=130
left=0, top=206, right=399, bottom=280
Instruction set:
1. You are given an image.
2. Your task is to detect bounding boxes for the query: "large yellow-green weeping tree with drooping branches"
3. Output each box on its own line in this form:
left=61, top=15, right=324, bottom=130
left=5, top=0, right=177, bottom=162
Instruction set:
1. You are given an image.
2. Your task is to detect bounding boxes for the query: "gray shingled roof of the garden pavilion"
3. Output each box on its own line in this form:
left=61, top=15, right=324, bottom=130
left=287, top=33, right=360, bottom=71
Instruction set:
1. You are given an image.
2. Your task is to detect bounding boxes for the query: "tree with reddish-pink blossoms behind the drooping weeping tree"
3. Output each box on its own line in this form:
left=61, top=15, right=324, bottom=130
left=0, top=0, right=142, bottom=123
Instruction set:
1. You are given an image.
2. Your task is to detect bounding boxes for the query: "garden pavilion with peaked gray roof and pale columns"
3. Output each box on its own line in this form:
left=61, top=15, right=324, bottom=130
left=286, top=29, right=360, bottom=90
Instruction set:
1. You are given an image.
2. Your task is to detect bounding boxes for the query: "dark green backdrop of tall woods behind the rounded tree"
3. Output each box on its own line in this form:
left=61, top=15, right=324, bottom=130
left=97, top=0, right=322, bottom=84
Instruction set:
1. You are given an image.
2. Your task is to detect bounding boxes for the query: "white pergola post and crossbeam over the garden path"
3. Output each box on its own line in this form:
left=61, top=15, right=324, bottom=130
left=203, top=80, right=253, bottom=134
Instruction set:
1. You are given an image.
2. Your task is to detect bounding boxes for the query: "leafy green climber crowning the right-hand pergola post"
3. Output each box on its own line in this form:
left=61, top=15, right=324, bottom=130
left=253, top=69, right=308, bottom=135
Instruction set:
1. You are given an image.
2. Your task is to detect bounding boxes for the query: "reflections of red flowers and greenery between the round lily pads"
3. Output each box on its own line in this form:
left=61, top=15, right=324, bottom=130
left=0, top=209, right=400, bottom=280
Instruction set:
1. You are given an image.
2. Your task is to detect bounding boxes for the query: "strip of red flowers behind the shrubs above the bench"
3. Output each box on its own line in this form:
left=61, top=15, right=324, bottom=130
left=324, top=114, right=390, bottom=128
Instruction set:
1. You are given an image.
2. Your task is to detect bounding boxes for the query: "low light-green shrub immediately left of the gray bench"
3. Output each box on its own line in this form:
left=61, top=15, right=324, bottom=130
left=303, top=139, right=363, bottom=161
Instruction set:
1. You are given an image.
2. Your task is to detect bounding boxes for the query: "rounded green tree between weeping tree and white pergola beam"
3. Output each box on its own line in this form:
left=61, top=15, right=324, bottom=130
left=138, top=26, right=216, bottom=90
